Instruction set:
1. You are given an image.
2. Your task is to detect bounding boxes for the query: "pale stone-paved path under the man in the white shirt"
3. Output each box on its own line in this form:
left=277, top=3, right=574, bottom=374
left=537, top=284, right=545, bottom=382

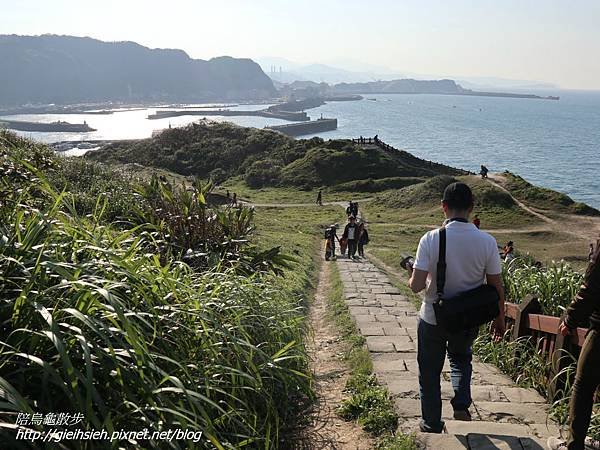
left=337, top=258, right=558, bottom=450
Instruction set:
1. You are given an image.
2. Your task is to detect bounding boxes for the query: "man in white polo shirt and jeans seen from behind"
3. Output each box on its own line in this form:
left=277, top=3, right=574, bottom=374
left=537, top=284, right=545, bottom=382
left=408, top=182, right=505, bottom=433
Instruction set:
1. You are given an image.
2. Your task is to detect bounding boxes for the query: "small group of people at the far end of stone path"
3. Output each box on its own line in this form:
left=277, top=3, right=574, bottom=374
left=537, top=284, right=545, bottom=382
left=325, top=201, right=369, bottom=261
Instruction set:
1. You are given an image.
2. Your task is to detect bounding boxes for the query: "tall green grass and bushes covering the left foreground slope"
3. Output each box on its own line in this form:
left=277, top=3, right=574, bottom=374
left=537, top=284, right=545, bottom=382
left=0, top=133, right=313, bottom=448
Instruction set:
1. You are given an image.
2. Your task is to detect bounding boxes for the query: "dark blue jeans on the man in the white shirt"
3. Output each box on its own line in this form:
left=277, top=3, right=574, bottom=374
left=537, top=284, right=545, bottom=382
left=417, top=319, right=479, bottom=433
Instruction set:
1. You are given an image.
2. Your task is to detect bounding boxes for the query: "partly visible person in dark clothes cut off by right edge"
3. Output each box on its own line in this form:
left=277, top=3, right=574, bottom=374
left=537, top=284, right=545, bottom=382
left=548, top=243, right=600, bottom=450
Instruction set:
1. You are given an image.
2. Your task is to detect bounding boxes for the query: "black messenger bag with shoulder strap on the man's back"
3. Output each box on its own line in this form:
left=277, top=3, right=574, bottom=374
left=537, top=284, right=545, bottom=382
left=433, top=227, right=500, bottom=333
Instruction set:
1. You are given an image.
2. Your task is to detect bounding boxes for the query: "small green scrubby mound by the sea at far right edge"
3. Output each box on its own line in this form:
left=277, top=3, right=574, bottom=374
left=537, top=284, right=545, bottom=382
left=504, top=171, right=600, bottom=216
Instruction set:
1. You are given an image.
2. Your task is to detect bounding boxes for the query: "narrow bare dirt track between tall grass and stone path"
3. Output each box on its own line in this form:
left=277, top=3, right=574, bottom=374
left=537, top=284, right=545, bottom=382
left=294, top=263, right=374, bottom=450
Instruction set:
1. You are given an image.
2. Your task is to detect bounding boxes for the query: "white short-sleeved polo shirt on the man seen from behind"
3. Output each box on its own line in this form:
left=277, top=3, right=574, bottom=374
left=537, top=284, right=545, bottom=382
left=414, top=221, right=502, bottom=325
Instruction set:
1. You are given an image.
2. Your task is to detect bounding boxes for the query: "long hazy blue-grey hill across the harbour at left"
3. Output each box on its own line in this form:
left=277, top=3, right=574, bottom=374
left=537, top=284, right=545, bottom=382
left=0, top=35, right=276, bottom=106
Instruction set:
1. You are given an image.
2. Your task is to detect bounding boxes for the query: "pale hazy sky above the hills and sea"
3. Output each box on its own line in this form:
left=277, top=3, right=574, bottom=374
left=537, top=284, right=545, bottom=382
left=0, top=0, right=600, bottom=89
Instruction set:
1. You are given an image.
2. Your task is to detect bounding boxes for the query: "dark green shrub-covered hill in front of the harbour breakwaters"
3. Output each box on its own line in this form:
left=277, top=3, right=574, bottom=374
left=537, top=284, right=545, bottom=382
left=86, top=122, right=466, bottom=190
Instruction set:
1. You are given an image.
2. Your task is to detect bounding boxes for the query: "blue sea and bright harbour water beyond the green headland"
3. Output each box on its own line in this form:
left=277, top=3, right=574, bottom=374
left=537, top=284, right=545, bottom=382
left=0, top=91, right=600, bottom=208
